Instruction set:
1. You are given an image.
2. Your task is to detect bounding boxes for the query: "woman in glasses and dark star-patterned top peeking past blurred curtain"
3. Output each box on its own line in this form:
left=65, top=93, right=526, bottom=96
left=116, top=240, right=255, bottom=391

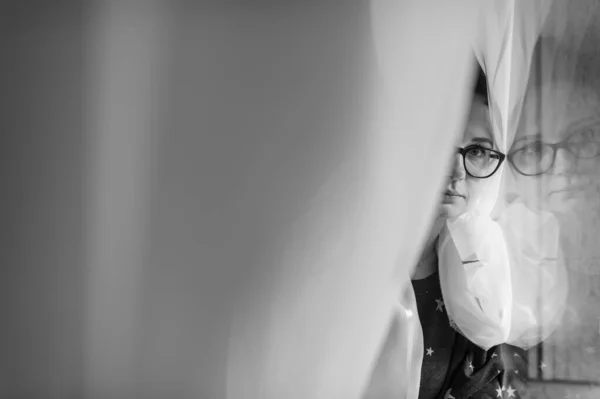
left=412, top=72, right=512, bottom=399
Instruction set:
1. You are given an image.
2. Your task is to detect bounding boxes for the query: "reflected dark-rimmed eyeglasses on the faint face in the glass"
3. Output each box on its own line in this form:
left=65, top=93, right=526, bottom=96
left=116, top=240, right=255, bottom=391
left=508, top=125, right=600, bottom=176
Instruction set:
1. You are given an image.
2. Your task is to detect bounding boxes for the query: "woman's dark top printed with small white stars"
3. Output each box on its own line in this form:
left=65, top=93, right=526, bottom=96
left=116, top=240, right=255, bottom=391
left=412, top=273, right=527, bottom=399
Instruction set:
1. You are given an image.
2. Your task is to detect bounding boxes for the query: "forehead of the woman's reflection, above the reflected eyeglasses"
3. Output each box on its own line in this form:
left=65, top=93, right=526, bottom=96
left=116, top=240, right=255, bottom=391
left=516, top=82, right=600, bottom=142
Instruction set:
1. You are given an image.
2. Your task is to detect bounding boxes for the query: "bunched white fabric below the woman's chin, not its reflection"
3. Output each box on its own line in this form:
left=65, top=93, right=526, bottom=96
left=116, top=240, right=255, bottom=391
left=438, top=214, right=513, bottom=350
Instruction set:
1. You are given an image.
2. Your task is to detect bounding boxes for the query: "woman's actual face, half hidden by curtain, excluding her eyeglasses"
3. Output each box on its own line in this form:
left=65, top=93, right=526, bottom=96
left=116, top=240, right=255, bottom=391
left=439, top=96, right=499, bottom=219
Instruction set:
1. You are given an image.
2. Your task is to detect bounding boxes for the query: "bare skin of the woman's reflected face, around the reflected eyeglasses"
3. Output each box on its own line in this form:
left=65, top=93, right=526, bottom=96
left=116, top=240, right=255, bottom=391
left=511, top=82, right=600, bottom=215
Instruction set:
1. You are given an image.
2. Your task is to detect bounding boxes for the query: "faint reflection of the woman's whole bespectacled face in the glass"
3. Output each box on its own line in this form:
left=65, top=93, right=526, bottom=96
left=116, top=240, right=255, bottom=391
left=508, top=76, right=600, bottom=218
